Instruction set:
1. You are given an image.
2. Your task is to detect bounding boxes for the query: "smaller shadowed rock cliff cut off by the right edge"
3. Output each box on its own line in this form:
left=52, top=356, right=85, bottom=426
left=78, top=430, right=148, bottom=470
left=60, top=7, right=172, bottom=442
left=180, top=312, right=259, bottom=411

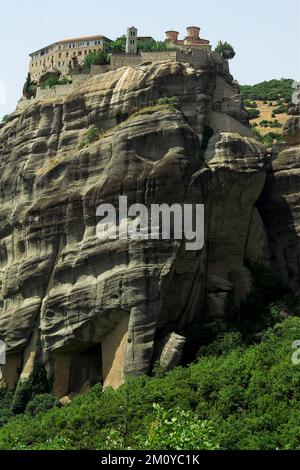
left=258, top=105, right=300, bottom=295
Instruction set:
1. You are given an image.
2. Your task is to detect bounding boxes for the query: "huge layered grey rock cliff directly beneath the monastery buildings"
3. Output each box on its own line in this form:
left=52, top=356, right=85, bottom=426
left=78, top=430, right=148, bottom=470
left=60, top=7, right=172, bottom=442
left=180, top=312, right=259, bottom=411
left=0, top=62, right=268, bottom=398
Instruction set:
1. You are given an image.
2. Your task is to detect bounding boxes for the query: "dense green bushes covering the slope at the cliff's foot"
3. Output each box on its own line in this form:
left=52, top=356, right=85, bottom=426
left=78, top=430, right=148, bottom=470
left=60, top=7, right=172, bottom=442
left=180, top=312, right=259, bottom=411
left=0, top=264, right=300, bottom=449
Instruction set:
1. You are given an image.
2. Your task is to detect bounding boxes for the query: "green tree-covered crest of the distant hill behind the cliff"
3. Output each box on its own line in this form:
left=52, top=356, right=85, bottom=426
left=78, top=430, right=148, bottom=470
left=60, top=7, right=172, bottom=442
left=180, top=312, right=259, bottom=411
left=241, top=78, right=294, bottom=103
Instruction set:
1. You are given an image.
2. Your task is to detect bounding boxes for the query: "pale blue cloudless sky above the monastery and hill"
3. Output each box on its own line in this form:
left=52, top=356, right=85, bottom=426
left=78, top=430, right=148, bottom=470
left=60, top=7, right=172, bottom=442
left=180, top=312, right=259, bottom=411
left=0, top=0, right=300, bottom=118
